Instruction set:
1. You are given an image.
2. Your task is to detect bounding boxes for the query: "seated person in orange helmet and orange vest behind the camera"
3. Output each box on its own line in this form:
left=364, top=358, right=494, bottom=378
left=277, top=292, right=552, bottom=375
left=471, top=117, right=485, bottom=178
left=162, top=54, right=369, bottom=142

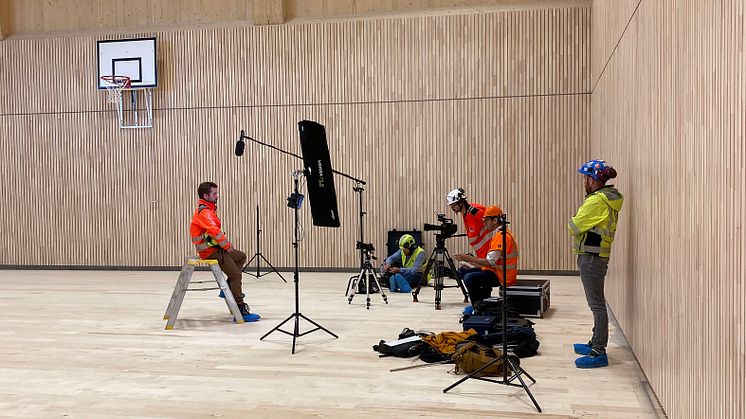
left=453, top=206, right=518, bottom=314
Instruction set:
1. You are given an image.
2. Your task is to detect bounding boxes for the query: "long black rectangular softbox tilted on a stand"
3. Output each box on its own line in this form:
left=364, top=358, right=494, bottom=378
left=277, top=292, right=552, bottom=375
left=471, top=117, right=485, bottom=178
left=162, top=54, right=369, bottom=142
left=298, top=121, right=339, bottom=227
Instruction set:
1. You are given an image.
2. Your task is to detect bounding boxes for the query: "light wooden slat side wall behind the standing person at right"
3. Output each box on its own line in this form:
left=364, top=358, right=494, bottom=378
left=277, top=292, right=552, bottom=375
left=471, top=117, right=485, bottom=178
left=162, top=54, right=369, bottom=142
left=591, top=0, right=746, bottom=418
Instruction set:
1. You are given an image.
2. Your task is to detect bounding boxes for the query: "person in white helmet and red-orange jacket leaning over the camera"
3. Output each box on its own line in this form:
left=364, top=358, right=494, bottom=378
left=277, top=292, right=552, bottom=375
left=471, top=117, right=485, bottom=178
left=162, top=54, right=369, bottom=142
left=446, top=188, right=492, bottom=278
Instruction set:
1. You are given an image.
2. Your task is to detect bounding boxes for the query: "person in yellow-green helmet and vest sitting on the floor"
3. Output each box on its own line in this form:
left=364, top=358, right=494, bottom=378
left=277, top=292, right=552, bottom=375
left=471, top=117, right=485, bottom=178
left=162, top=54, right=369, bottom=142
left=382, top=234, right=425, bottom=292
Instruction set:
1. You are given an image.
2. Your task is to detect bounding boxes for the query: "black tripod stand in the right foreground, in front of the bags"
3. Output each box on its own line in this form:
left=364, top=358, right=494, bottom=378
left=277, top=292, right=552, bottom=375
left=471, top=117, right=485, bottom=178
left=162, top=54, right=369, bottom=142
left=443, top=214, right=541, bottom=413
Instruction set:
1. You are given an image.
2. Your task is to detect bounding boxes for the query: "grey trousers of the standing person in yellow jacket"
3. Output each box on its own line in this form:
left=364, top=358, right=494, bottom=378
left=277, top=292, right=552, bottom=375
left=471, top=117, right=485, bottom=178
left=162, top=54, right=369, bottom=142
left=578, top=254, right=609, bottom=353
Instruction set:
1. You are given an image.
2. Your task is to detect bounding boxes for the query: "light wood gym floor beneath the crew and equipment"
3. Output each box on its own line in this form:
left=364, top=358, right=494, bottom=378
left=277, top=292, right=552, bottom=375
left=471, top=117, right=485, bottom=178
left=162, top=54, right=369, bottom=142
left=0, top=271, right=657, bottom=418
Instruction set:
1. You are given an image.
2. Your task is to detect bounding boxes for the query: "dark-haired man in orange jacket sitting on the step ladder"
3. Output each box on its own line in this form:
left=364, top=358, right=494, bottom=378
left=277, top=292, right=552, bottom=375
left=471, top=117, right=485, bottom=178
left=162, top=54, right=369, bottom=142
left=189, top=182, right=261, bottom=322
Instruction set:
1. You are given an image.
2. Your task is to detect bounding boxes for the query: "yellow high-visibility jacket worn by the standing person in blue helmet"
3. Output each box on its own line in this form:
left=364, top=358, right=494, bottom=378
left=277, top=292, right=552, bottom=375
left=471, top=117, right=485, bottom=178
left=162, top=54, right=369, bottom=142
left=567, top=185, right=624, bottom=257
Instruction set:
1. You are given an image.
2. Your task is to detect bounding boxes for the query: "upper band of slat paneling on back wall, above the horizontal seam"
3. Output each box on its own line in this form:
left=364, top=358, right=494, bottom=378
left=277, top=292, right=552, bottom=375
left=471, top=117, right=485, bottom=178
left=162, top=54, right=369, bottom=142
left=0, top=8, right=588, bottom=114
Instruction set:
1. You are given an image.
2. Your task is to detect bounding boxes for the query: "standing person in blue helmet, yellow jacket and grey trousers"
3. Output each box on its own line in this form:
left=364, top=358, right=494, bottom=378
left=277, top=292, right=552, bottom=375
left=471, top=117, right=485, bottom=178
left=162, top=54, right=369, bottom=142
left=567, top=160, right=624, bottom=368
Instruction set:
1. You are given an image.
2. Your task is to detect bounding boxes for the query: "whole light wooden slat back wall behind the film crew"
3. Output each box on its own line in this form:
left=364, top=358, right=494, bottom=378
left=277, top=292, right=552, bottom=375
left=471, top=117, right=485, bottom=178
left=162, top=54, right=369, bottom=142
left=0, top=8, right=590, bottom=270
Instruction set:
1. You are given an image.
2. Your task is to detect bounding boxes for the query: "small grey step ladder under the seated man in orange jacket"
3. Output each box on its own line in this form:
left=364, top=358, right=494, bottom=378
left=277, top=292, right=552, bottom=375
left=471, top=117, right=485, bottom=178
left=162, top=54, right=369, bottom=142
left=163, top=257, right=244, bottom=330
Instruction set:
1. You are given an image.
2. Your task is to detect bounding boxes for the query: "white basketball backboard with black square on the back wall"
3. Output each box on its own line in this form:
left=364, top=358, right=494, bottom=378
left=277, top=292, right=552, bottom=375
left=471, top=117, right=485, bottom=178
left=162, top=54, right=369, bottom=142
left=96, top=38, right=158, bottom=89
